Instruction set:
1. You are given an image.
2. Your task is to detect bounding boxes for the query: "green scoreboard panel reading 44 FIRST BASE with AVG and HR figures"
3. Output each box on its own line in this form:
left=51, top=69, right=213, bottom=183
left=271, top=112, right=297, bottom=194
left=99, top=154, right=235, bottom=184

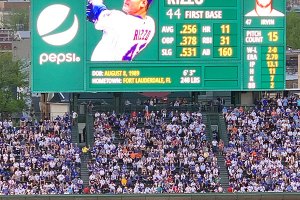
left=159, top=0, right=241, bottom=61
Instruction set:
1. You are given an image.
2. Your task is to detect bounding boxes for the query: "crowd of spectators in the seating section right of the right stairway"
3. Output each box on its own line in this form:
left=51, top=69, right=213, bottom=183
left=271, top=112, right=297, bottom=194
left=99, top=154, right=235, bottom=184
left=223, top=96, right=300, bottom=192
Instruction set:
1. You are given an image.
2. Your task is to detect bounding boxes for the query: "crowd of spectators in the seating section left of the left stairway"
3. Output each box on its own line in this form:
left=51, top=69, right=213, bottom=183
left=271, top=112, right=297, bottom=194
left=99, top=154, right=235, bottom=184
left=0, top=113, right=83, bottom=195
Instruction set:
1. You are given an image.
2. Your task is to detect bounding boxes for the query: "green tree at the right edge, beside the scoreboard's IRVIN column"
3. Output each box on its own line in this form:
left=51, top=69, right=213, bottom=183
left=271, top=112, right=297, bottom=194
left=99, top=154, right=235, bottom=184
left=286, top=12, right=300, bottom=49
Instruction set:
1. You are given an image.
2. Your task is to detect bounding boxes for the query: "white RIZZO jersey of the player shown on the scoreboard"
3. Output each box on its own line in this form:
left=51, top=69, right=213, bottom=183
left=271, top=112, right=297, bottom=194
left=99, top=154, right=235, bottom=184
left=91, top=10, right=155, bottom=61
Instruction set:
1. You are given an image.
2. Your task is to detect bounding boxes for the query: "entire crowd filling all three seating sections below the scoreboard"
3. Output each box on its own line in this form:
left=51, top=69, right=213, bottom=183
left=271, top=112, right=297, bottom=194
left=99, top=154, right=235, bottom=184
left=0, top=92, right=300, bottom=195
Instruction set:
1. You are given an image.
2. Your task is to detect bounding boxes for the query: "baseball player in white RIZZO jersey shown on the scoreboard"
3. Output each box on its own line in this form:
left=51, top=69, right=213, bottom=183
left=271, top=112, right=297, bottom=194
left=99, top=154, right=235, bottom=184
left=86, top=0, right=155, bottom=61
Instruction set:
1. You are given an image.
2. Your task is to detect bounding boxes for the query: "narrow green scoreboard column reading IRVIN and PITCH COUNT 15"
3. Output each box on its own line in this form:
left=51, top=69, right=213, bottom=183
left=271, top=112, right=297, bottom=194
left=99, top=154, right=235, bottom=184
left=243, top=0, right=286, bottom=90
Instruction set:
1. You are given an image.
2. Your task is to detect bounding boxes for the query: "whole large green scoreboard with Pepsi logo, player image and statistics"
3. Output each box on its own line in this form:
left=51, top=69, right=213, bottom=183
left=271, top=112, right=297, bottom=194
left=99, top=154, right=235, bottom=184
left=31, top=0, right=286, bottom=92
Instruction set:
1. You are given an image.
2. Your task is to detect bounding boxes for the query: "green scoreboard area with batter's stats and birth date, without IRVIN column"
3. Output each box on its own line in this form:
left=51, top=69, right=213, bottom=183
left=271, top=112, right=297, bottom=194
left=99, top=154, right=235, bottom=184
left=89, top=0, right=244, bottom=91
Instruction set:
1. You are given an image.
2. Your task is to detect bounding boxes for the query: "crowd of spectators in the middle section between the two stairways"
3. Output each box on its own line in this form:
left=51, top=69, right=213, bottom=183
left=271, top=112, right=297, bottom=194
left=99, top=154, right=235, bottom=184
left=88, top=110, right=223, bottom=194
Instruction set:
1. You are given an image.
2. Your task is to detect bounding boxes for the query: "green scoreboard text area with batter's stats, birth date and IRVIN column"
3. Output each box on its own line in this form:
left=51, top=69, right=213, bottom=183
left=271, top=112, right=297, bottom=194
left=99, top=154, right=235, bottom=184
left=89, top=0, right=285, bottom=91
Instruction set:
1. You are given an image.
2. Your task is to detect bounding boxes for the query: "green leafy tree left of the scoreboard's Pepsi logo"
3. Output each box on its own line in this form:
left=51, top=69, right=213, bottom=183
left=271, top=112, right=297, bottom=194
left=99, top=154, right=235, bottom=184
left=0, top=53, right=27, bottom=118
